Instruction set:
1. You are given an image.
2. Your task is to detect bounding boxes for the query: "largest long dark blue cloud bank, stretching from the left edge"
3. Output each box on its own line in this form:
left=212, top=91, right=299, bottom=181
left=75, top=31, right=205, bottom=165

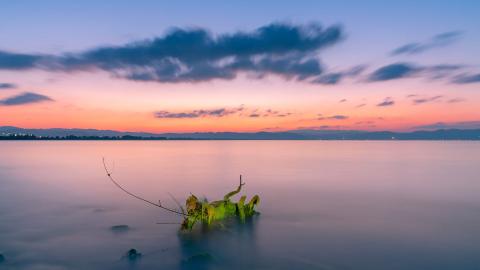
left=0, top=23, right=344, bottom=83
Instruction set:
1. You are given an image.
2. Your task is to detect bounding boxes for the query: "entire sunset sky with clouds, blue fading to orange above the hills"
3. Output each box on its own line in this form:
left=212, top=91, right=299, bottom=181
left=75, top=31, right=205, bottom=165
left=0, top=0, right=480, bottom=132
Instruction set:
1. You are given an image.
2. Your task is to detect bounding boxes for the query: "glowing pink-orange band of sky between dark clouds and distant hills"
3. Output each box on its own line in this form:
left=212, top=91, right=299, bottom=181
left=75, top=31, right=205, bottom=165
left=0, top=72, right=480, bottom=133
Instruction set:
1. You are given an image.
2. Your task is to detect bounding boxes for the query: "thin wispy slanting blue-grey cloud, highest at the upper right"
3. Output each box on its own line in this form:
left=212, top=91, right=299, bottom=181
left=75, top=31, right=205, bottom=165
left=391, top=31, right=463, bottom=55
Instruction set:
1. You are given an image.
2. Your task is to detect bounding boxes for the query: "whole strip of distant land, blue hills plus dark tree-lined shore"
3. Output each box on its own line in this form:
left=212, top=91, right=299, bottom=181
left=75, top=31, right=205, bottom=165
left=0, top=126, right=480, bottom=141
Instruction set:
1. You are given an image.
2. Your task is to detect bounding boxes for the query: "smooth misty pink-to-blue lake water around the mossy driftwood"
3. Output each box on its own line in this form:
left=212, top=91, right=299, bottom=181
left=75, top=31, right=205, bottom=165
left=0, top=141, right=480, bottom=270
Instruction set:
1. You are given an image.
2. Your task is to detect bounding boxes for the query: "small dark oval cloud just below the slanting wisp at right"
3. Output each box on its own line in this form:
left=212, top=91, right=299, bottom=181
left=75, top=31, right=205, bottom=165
left=368, top=63, right=421, bottom=82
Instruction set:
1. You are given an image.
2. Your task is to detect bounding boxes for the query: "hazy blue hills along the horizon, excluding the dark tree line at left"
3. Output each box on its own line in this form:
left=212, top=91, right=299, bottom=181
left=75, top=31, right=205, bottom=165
left=0, top=126, right=480, bottom=140
